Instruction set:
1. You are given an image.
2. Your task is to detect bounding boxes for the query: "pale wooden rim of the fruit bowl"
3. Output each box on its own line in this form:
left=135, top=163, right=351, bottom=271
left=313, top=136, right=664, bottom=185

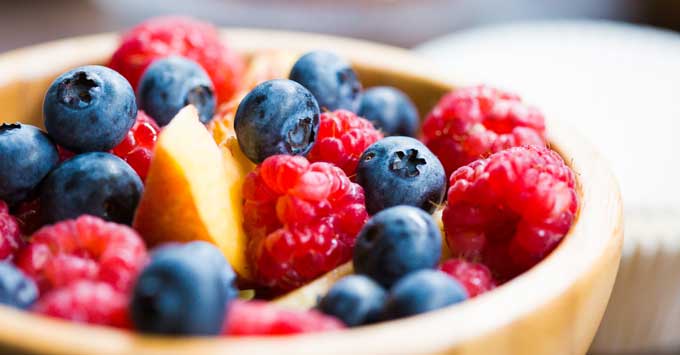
left=0, top=28, right=622, bottom=354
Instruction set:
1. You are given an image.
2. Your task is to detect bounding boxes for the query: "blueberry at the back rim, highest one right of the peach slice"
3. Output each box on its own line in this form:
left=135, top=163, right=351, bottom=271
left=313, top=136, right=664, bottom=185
left=289, top=51, right=361, bottom=112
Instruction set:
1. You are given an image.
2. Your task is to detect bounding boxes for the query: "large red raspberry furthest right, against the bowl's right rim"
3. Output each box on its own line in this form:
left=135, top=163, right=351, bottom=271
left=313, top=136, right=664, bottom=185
left=442, top=146, right=578, bottom=281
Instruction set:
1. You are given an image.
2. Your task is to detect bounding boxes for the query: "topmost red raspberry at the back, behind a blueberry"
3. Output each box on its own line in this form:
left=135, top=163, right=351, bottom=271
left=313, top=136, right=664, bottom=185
left=109, top=16, right=245, bottom=103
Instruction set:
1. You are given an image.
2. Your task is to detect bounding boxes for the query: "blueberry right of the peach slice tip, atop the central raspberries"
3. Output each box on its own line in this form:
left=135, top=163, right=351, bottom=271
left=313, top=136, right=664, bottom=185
left=234, top=79, right=319, bottom=163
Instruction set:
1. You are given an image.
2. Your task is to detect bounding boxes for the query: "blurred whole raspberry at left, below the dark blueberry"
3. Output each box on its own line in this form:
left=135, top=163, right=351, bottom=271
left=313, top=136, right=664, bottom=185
left=17, top=216, right=147, bottom=293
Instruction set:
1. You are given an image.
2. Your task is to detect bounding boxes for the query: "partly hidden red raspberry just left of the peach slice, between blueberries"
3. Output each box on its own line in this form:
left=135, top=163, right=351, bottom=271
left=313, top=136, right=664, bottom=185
left=111, top=111, right=161, bottom=181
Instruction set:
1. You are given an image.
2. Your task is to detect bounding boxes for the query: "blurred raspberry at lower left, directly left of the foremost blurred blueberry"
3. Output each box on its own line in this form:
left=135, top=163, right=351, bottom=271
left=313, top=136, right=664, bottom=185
left=33, top=280, right=130, bottom=328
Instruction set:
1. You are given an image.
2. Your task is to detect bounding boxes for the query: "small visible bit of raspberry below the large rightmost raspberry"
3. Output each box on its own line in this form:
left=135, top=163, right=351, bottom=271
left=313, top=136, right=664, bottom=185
left=439, top=259, right=496, bottom=298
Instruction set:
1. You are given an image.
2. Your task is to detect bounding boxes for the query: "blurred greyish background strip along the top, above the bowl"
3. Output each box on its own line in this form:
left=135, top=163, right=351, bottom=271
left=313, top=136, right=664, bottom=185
left=0, top=0, right=680, bottom=51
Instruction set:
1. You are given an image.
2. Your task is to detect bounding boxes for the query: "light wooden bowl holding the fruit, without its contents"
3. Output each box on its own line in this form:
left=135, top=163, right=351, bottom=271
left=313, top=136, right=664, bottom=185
left=0, top=29, right=623, bottom=355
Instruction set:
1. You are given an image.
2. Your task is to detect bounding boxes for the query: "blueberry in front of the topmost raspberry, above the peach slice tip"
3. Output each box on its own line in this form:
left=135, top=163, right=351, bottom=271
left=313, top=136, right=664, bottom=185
left=137, top=56, right=215, bottom=126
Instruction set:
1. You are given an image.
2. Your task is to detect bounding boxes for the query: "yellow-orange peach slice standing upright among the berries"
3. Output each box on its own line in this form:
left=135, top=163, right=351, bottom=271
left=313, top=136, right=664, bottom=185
left=133, top=106, right=250, bottom=278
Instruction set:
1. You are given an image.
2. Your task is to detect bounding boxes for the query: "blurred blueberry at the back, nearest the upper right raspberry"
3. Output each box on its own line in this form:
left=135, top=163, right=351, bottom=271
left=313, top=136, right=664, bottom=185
left=358, top=86, right=420, bottom=137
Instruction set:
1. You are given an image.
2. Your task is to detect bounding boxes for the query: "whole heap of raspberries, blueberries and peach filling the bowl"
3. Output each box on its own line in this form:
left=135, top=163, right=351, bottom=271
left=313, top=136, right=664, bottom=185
left=0, top=17, right=579, bottom=336
